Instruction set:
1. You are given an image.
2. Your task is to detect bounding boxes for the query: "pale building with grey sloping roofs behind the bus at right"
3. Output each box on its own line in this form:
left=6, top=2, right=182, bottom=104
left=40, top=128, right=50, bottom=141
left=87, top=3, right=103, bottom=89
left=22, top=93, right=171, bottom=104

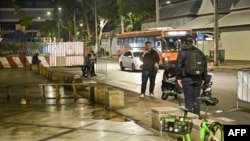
left=141, top=0, right=250, bottom=61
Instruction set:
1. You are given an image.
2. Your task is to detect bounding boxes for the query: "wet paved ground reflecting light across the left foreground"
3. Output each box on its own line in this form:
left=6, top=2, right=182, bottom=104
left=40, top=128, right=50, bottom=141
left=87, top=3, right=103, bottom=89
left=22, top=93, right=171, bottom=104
left=0, top=60, right=249, bottom=141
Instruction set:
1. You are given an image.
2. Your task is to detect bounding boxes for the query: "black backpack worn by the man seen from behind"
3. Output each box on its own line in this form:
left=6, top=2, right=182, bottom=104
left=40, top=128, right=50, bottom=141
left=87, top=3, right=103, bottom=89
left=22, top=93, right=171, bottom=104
left=184, top=47, right=206, bottom=75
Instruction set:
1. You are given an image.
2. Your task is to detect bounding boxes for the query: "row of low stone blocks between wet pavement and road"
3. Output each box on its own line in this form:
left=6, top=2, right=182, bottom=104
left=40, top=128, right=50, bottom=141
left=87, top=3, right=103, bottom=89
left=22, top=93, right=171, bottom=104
left=31, top=66, right=125, bottom=109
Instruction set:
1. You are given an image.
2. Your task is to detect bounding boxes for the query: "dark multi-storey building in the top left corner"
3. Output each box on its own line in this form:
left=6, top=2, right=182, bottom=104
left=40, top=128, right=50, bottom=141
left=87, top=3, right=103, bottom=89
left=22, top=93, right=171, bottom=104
left=0, top=0, right=53, bottom=37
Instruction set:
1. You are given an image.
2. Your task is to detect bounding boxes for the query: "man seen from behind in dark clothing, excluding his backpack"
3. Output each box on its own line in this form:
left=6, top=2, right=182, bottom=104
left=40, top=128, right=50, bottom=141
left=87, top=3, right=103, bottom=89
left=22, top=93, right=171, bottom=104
left=176, top=38, right=207, bottom=115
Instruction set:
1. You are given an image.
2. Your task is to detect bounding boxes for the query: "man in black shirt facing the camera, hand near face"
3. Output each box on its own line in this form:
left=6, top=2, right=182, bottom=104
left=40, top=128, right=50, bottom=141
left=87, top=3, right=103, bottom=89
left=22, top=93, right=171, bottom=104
left=140, top=41, right=159, bottom=98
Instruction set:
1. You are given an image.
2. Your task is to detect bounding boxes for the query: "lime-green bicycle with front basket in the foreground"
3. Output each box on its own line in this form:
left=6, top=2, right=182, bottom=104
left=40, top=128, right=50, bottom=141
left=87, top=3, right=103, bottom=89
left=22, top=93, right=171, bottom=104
left=160, top=96, right=224, bottom=141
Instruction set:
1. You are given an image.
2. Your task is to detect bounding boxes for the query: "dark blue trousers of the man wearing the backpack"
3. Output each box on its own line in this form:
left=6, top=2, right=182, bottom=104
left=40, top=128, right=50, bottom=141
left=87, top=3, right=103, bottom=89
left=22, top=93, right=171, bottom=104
left=182, top=78, right=201, bottom=115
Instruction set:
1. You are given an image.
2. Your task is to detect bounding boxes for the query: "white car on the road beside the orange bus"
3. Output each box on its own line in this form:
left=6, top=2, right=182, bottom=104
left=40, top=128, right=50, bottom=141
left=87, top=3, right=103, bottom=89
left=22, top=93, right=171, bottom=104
left=119, top=50, right=143, bottom=71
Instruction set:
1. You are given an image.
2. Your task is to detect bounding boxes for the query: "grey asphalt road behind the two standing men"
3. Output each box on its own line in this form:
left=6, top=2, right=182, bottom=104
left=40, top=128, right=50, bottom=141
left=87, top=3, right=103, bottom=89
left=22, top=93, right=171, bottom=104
left=92, top=60, right=250, bottom=124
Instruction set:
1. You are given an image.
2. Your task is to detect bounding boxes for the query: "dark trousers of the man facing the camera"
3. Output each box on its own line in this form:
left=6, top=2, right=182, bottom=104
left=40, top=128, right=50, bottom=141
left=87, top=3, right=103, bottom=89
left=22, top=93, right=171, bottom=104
left=141, top=68, right=158, bottom=94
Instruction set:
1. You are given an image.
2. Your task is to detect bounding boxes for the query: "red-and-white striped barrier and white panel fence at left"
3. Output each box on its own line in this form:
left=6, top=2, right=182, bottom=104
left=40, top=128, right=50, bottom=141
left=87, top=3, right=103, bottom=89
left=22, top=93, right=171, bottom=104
left=0, top=42, right=86, bottom=69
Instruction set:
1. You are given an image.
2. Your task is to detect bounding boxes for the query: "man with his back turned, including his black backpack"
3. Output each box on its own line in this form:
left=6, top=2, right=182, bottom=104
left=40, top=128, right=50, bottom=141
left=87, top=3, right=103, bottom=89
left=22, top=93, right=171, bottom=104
left=176, top=38, right=207, bottom=116
